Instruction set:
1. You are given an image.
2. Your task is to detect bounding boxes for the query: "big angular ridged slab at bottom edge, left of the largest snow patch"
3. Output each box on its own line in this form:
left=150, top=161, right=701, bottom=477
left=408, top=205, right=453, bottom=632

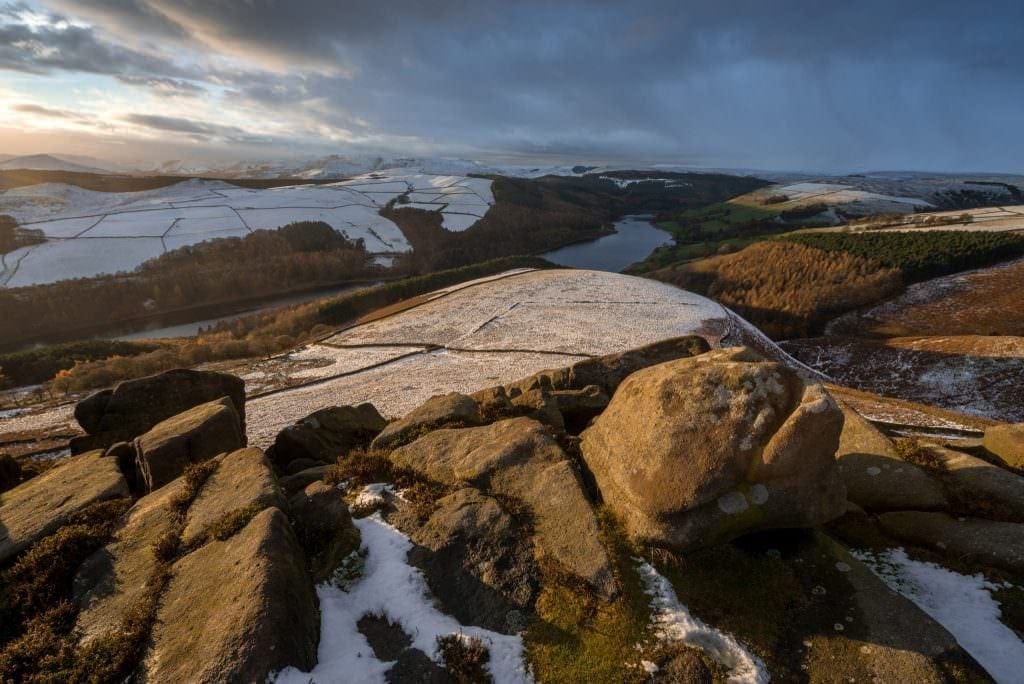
left=141, top=508, right=319, bottom=684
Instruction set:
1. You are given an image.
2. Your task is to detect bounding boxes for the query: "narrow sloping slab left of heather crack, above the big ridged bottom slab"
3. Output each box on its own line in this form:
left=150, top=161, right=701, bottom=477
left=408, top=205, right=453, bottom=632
left=73, top=478, right=184, bottom=644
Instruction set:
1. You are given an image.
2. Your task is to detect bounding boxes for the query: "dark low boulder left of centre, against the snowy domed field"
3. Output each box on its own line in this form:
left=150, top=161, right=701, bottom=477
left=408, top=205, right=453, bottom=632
left=267, top=403, right=387, bottom=471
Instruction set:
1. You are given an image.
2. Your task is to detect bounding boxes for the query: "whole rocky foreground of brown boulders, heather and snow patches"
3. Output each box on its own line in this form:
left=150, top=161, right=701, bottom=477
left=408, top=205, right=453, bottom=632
left=0, top=336, right=1024, bottom=682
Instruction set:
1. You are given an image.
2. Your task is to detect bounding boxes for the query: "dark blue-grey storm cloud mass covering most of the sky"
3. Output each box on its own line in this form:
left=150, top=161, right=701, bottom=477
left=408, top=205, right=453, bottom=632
left=16, top=0, right=1024, bottom=170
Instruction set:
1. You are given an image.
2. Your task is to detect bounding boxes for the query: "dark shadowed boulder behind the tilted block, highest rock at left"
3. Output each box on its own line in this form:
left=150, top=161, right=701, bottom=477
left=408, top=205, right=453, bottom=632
left=72, top=369, right=246, bottom=453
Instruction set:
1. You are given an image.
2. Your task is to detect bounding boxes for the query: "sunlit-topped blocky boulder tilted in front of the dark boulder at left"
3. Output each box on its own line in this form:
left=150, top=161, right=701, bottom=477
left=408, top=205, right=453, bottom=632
left=134, top=397, right=246, bottom=491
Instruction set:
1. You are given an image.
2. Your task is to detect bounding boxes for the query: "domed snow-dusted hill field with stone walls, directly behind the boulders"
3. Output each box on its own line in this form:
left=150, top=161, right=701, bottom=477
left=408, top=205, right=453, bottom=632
left=247, top=270, right=797, bottom=446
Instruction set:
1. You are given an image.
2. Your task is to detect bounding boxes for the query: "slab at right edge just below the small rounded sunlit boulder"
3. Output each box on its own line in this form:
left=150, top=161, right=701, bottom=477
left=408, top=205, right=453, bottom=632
left=928, top=444, right=1024, bottom=522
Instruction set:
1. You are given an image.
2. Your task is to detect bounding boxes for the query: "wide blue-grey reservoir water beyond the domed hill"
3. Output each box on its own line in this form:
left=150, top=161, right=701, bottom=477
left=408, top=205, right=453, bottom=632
left=541, top=216, right=672, bottom=273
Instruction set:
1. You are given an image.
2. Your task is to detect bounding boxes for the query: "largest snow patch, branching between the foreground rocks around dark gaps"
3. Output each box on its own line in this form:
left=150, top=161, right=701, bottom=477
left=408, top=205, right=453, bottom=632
left=276, top=514, right=531, bottom=684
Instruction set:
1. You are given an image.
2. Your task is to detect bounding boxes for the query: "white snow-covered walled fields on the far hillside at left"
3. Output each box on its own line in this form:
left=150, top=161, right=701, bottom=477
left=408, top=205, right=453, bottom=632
left=0, top=170, right=495, bottom=287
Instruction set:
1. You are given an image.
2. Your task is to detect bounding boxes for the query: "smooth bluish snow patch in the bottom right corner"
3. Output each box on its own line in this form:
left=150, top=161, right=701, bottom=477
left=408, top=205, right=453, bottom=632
left=853, top=549, right=1024, bottom=684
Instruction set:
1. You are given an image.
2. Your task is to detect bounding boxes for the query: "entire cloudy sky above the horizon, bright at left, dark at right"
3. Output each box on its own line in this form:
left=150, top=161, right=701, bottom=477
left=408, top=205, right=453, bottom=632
left=0, top=0, right=1024, bottom=172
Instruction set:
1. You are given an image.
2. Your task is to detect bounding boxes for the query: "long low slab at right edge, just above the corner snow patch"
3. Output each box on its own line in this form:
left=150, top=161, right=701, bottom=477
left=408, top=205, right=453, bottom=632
left=879, top=511, right=1024, bottom=572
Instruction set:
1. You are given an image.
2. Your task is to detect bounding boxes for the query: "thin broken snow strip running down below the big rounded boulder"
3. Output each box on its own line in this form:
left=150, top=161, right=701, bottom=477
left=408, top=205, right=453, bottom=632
left=636, top=558, right=771, bottom=684
